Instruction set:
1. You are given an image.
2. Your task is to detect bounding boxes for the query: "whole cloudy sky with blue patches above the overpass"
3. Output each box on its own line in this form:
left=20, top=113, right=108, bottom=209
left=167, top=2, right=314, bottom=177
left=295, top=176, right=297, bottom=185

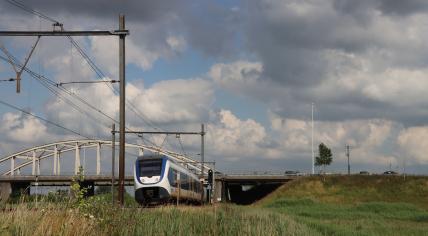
left=0, top=0, right=428, bottom=174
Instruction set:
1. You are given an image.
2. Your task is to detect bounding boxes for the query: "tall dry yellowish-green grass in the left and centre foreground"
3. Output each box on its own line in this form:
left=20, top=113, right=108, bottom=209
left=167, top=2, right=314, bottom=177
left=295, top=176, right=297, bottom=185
left=0, top=203, right=318, bottom=235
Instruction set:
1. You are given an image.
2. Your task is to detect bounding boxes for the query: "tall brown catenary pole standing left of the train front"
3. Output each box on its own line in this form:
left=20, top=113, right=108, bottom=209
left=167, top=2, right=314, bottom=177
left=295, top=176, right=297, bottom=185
left=119, top=15, right=126, bottom=206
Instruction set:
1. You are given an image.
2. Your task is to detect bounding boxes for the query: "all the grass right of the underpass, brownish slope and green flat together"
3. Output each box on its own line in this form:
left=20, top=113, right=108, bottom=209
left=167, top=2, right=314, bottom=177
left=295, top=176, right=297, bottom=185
left=257, top=176, right=428, bottom=235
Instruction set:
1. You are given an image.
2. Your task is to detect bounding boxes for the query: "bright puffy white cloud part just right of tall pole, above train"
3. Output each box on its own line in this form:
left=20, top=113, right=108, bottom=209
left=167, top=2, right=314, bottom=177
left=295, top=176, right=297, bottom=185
left=127, top=79, right=214, bottom=125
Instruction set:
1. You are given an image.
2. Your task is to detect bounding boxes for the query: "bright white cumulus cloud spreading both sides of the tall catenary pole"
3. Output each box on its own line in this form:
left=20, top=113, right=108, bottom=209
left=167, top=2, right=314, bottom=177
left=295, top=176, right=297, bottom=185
left=45, top=79, right=213, bottom=136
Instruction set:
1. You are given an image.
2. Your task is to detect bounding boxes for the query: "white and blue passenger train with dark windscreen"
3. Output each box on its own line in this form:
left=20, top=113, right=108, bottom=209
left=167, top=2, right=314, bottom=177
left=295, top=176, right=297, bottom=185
left=134, top=155, right=203, bottom=205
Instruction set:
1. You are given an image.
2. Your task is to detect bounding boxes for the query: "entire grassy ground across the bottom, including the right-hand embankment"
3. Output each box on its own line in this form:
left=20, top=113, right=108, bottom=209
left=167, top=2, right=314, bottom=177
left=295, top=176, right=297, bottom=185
left=0, top=176, right=428, bottom=236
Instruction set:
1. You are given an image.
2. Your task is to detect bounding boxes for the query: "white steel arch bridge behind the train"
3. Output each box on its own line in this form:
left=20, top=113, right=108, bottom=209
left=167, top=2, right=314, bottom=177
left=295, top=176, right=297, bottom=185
left=0, top=139, right=212, bottom=177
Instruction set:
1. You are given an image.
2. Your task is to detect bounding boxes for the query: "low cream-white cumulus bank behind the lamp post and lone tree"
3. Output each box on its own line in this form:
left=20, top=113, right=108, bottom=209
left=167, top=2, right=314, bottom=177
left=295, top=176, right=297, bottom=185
left=271, top=114, right=401, bottom=166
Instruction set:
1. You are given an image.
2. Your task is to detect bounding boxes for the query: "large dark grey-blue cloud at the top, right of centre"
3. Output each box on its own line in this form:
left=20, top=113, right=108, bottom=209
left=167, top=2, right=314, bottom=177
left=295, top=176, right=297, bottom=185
left=245, top=1, right=368, bottom=87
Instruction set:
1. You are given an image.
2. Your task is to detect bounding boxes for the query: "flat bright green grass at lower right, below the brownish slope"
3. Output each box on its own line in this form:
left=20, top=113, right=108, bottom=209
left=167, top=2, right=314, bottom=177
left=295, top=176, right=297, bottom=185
left=265, top=199, right=428, bottom=235
